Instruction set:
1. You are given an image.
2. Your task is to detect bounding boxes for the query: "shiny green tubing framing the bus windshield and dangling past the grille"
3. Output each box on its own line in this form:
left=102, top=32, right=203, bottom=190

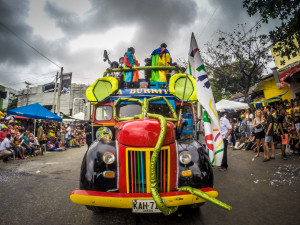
left=113, top=96, right=231, bottom=216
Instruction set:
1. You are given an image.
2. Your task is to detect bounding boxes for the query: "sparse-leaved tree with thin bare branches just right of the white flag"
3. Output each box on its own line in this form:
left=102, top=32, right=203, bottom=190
left=202, top=24, right=272, bottom=107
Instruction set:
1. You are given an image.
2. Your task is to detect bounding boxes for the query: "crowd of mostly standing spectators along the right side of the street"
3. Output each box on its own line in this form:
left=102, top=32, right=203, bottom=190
left=227, top=96, right=300, bottom=161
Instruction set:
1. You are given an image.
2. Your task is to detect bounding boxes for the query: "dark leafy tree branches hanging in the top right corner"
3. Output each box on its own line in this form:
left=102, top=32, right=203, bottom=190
left=243, top=0, right=300, bottom=64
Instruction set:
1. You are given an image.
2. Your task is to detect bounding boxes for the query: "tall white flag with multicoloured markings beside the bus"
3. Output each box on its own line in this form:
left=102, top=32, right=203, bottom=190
left=189, top=33, right=224, bottom=166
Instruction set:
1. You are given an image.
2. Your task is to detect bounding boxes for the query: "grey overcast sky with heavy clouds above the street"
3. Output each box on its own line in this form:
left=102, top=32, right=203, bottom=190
left=0, top=0, right=276, bottom=89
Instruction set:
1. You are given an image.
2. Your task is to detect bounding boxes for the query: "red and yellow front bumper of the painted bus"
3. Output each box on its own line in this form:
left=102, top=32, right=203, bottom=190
left=70, top=188, right=218, bottom=209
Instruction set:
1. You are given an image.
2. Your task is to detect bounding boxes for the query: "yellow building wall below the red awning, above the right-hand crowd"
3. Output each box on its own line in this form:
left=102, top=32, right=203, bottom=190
left=256, top=77, right=291, bottom=106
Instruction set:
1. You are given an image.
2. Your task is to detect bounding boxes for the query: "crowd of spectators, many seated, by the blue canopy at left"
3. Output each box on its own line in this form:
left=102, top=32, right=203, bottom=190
left=0, top=117, right=86, bottom=162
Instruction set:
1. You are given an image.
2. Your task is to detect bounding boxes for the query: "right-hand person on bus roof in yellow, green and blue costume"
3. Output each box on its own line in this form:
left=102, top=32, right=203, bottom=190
left=151, top=43, right=171, bottom=82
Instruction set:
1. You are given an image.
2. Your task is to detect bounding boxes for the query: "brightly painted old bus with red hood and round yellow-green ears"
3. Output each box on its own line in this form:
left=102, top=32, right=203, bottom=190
left=70, top=66, right=230, bottom=215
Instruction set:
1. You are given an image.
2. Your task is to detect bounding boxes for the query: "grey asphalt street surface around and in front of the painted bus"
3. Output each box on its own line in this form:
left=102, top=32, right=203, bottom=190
left=0, top=147, right=300, bottom=225
